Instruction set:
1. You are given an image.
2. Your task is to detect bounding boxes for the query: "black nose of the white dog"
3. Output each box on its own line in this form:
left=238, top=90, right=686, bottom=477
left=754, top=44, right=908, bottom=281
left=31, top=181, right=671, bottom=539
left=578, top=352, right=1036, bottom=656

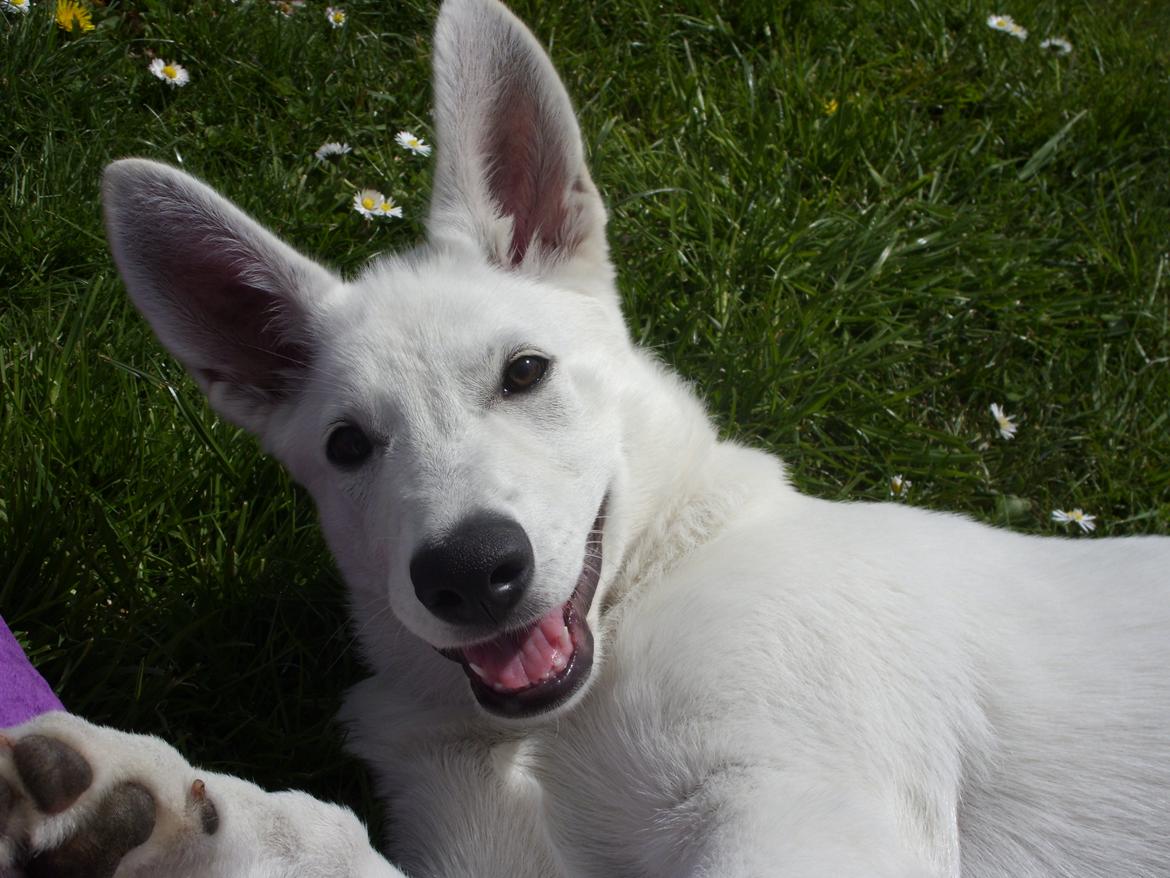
left=411, top=513, right=532, bottom=626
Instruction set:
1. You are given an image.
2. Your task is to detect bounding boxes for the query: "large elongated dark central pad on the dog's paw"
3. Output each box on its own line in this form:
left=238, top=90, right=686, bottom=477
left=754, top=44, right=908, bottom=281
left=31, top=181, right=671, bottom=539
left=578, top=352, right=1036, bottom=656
left=25, top=782, right=156, bottom=878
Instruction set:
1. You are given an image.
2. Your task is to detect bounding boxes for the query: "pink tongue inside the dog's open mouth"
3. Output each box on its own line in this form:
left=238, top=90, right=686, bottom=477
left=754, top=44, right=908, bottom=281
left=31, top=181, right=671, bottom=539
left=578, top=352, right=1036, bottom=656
left=463, top=606, right=573, bottom=692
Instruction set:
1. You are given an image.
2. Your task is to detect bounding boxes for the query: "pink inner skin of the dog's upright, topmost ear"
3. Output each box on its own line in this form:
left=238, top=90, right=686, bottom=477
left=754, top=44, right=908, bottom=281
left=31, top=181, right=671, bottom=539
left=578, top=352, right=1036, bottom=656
left=484, top=77, right=577, bottom=266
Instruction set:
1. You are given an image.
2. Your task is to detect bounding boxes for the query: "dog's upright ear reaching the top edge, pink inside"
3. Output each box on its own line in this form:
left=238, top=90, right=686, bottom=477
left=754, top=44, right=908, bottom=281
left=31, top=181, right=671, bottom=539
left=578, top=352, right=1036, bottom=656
left=428, top=0, right=611, bottom=289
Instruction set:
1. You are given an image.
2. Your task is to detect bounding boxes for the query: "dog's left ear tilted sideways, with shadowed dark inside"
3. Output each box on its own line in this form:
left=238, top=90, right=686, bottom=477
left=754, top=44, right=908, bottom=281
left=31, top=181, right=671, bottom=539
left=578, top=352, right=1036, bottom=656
left=102, top=159, right=339, bottom=433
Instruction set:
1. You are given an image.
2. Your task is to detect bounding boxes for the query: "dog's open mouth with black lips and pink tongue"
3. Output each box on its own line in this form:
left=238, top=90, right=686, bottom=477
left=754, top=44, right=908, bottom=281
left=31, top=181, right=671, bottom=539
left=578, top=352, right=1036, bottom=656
left=440, top=501, right=605, bottom=718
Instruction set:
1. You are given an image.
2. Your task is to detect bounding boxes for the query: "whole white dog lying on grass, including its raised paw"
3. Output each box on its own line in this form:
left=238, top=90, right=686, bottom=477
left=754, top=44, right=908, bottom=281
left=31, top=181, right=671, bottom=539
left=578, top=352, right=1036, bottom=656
left=0, top=0, right=1170, bottom=878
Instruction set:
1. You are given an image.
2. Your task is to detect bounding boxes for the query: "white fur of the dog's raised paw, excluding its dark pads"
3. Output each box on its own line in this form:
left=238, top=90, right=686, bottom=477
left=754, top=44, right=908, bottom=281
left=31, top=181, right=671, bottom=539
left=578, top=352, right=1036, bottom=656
left=0, top=712, right=401, bottom=878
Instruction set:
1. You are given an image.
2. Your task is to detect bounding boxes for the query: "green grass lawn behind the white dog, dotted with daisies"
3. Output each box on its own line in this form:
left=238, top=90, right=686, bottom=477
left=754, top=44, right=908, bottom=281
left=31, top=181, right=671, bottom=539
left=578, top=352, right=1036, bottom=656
left=0, top=0, right=1170, bottom=833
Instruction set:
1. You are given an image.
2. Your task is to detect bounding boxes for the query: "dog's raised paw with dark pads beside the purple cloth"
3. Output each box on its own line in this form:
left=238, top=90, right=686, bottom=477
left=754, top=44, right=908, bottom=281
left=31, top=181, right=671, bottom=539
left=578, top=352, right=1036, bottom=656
left=0, top=713, right=399, bottom=878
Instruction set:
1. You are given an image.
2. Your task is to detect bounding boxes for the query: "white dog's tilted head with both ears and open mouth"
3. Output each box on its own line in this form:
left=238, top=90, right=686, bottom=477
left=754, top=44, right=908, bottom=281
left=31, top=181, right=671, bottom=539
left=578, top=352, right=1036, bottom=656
left=103, top=0, right=633, bottom=716
